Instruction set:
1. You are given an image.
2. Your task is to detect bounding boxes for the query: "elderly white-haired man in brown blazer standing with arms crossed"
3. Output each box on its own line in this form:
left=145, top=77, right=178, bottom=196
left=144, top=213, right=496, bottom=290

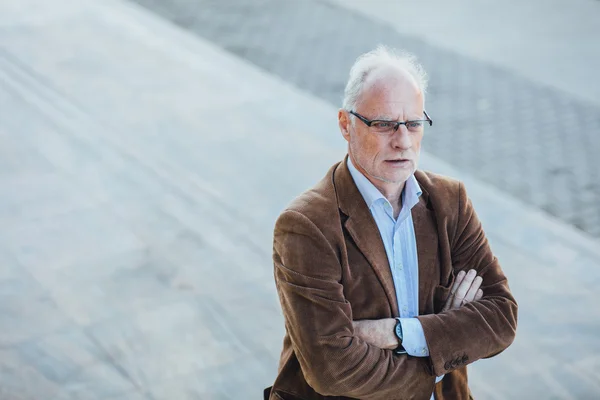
left=265, top=47, right=517, bottom=400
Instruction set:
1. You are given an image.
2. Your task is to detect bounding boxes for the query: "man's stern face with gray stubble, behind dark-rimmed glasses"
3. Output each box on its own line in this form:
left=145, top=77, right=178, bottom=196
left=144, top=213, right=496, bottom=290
left=338, top=69, right=424, bottom=191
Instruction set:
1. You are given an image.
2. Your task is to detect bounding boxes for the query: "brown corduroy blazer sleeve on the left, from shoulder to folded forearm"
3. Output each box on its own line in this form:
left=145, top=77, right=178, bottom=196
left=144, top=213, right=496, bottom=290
left=273, top=210, right=434, bottom=399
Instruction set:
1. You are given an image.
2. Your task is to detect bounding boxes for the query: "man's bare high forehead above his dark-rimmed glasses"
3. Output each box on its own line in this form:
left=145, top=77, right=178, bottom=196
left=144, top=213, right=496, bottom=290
left=358, top=67, right=424, bottom=118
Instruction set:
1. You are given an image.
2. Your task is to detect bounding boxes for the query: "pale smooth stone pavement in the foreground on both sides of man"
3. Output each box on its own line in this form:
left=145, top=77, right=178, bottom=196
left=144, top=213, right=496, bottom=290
left=0, top=0, right=600, bottom=400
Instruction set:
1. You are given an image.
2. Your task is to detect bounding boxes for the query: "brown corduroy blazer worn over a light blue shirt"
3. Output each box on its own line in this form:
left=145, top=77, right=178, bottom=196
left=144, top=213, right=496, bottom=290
left=265, top=160, right=517, bottom=400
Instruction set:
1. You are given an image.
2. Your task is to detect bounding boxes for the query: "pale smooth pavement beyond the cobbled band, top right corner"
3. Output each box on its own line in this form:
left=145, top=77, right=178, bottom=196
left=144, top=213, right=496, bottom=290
left=327, top=0, right=600, bottom=106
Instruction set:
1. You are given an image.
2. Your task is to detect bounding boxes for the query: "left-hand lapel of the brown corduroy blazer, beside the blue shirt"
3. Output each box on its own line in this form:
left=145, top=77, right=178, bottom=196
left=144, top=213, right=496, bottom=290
left=333, top=156, right=400, bottom=317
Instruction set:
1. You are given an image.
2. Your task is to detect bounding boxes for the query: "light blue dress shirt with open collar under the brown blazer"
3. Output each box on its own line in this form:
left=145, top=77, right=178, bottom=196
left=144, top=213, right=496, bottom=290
left=348, top=158, right=443, bottom=398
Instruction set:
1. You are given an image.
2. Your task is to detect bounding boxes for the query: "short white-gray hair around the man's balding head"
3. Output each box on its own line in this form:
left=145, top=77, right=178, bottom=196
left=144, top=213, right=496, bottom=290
left=342, top=45, right=427, bottom=111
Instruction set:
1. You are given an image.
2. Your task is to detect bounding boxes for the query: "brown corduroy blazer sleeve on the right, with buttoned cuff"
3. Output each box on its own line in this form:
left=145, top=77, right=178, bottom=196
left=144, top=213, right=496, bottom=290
left=418, top=183, right=517, bottom=375
